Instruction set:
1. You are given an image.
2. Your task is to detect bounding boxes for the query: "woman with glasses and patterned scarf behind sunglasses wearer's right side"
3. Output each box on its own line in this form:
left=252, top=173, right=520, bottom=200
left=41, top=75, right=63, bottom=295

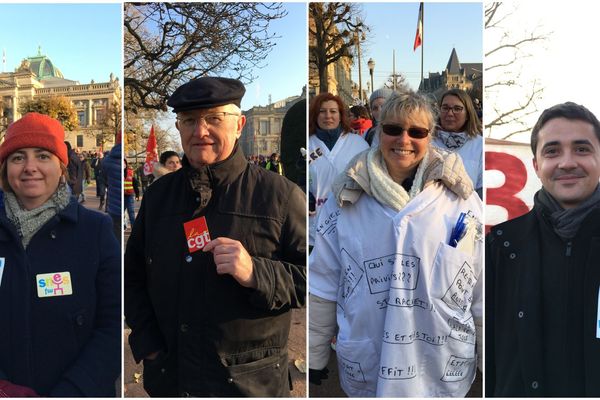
left=433, top=89, right=483, bottom=198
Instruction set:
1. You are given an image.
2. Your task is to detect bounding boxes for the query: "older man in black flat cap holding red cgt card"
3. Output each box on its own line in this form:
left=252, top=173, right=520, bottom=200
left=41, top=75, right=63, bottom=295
left=125, top=77, right=306, bottom=397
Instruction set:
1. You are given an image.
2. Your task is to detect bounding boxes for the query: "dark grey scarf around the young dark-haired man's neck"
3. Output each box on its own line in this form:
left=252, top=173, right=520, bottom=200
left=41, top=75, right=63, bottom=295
left=533, top=185, right=600, bottom=240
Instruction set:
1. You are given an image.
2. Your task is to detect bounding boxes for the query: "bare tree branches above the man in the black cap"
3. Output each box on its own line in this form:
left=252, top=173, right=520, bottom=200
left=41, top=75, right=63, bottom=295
left=123, top=2, right=287, bottom=112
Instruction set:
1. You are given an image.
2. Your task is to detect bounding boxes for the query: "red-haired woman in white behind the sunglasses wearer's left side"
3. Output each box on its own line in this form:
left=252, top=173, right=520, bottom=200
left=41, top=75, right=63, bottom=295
left=308, top=93, right=369, bottom=246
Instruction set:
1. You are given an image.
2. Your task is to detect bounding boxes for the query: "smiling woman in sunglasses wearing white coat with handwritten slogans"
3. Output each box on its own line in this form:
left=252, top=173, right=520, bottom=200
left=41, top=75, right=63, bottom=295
left=309, top=92, right=482, bottom=397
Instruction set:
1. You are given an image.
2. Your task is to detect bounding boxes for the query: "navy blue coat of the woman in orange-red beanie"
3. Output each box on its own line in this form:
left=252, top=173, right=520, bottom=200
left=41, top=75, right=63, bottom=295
left=0, top=200, right=121, bottom=397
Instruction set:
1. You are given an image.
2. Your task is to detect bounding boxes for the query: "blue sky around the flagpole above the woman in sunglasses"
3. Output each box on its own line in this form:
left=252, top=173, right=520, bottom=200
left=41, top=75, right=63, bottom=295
left=352, top=2, right=483, bottom=93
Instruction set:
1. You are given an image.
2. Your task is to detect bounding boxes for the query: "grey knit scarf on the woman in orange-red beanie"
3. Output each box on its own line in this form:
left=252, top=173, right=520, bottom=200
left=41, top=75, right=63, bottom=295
left=4, top=182, right=71, bottom=248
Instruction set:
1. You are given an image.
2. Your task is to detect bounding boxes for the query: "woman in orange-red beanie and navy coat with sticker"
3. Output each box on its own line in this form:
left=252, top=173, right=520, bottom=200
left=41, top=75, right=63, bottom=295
left=0, top=113, right=121, bottom=397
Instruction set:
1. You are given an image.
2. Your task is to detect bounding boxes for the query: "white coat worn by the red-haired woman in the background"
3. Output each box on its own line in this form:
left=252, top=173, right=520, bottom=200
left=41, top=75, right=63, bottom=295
left=308, top=133, right=369, bottom=246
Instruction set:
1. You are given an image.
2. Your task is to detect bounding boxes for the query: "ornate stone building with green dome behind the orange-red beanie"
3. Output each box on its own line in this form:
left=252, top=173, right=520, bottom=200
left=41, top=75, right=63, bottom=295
left=0, top=48, right=121, bottom=151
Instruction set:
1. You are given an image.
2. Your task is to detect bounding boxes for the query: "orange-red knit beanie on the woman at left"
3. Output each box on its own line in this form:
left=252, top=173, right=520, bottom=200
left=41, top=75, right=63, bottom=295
left=0, top=113, right=69, bottom=165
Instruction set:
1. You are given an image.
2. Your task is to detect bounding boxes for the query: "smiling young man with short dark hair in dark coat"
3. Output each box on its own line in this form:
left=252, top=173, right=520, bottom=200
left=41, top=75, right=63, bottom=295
left=485, top=103, right=600, bottom=397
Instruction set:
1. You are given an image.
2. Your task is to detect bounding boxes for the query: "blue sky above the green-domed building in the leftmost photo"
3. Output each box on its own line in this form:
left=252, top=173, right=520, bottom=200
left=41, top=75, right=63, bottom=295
left=0, top=4, right=123, bottom=84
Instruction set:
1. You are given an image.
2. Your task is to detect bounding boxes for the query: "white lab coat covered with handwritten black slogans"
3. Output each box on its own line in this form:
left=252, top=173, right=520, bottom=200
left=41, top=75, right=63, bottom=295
left=309, top=183, right=483, bottom=397
